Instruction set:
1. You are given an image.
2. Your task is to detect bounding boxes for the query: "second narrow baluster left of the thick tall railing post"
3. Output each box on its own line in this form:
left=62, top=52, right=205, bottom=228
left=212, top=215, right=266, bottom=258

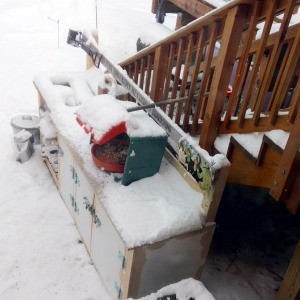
left=182, top=28, right=207, bottom=130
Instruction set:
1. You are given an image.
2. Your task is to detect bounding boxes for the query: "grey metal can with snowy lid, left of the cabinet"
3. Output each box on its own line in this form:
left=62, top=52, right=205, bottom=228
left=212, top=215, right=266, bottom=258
left=10, top=115, right=40, bottom=145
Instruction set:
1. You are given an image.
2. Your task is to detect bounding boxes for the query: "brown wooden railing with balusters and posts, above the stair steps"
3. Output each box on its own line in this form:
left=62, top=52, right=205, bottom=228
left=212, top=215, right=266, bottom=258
left=121, top=0, right=300, bottom=152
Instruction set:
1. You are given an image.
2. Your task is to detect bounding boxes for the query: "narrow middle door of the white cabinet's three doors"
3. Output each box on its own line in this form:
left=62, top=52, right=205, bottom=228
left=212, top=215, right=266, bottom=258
left=75, top=166, right=94, bottom=252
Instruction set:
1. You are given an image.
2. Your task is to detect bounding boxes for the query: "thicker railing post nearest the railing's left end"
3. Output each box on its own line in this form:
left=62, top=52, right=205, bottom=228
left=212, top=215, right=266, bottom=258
left=150, top=45, right=168, bottom=102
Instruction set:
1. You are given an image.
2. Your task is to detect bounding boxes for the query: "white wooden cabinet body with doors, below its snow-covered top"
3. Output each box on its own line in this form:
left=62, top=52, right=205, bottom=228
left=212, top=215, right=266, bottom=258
left=43, top=134, right=215, bottom=299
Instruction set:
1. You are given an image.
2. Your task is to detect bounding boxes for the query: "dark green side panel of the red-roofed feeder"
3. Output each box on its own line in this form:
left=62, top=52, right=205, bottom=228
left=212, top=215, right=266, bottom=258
left=122, top=136, right=167, bottom=185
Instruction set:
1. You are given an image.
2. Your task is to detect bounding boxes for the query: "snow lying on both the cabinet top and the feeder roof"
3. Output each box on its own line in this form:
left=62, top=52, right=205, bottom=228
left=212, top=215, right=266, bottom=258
left=35, top=72, right=205, bottom=248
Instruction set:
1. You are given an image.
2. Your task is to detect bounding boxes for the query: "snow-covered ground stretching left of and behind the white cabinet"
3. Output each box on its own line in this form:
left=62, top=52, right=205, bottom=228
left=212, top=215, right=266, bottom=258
left=0, top=0, right=175, bottom=300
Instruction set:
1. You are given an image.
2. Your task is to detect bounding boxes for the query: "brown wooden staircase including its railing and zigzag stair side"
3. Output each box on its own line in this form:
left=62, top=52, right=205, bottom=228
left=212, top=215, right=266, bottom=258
left=120, top=0, right=300, bottom=214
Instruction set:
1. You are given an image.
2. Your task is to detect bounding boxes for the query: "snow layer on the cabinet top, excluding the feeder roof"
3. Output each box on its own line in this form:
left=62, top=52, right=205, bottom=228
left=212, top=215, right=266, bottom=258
left=34, top=72, right=205, bottom=248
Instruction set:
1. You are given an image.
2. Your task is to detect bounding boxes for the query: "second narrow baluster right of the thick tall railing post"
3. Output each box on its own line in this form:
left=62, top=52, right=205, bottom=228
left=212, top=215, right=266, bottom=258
left=238, top=0, right=278, bottom=128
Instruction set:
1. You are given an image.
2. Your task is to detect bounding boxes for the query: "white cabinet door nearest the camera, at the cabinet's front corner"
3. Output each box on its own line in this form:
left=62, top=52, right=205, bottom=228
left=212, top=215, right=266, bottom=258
left=91, top=198, right=126, bottom=299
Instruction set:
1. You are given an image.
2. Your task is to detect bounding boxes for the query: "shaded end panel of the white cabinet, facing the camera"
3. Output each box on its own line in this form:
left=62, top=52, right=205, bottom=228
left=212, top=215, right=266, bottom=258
left=128, top=223, right=215, bottom=299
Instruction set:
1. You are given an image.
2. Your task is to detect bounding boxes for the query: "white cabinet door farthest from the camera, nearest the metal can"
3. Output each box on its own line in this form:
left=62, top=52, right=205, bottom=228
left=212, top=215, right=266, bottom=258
left=58, top=135, right=77, bottom=217
